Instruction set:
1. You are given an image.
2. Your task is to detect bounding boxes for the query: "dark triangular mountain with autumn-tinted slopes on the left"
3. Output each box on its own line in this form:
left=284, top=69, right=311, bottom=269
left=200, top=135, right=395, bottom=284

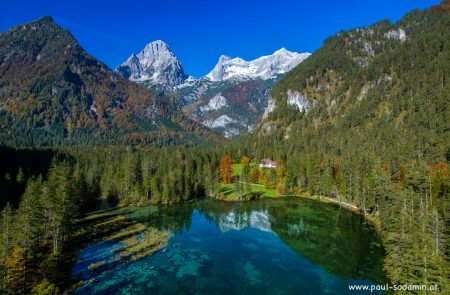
left=0, top=17, right=220, bottom=146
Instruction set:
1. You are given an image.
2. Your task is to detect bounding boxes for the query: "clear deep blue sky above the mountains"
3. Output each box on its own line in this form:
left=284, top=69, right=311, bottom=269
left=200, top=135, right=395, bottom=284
left=0, top=0, right=440, bottom=77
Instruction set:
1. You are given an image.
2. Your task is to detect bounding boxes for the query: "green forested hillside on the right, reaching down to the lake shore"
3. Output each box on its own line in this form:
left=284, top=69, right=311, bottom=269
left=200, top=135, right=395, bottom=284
left=236, top=1, right=450, bottom=292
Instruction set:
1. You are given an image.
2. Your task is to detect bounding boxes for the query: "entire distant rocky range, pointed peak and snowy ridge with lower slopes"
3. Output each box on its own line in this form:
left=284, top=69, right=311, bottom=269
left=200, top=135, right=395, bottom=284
left=116, top=40, right=311, bottom=137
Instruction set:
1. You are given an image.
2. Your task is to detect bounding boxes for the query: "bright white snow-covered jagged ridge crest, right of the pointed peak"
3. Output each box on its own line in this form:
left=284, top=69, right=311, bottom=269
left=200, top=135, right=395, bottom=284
left=204, top=47, right=311, bottom=81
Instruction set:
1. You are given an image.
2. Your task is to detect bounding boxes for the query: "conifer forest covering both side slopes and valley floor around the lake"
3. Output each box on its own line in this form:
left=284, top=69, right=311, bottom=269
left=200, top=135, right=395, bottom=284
left=0, top=1, right=450, bottom=294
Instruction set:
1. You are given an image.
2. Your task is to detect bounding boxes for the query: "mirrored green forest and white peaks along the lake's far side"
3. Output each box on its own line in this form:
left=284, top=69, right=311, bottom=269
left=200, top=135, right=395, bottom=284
left=120, top=198, right=384, bottom=281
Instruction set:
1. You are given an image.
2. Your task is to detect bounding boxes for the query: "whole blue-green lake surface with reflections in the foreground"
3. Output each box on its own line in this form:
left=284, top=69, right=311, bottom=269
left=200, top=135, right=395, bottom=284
left=73, top=198, right=384, bottom=294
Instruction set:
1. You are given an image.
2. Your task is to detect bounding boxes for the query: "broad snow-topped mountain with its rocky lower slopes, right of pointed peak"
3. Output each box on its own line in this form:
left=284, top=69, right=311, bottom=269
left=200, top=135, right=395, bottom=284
left=176, top=48, right=311, bottom=138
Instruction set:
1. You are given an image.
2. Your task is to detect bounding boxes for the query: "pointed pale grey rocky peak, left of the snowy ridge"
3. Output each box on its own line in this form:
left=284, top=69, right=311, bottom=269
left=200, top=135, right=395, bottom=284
left=116, top=40, right=188, bottom=90
